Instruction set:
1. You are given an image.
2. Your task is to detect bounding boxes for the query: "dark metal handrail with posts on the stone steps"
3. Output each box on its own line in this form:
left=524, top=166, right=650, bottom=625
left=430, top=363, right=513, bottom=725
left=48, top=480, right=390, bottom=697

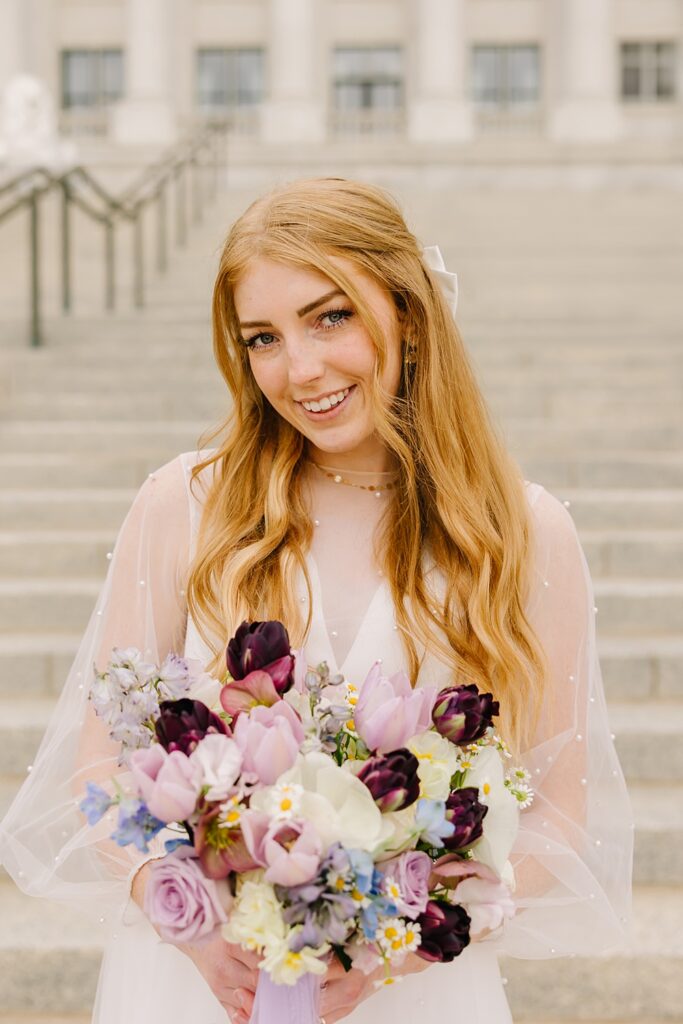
left=0, top=122, right=227, bottom=347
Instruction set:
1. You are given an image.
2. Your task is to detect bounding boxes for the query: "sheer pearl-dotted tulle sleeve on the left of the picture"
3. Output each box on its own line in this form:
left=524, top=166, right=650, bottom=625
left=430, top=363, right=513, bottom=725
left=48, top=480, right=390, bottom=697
left=0, top=454, right=197, bottom=914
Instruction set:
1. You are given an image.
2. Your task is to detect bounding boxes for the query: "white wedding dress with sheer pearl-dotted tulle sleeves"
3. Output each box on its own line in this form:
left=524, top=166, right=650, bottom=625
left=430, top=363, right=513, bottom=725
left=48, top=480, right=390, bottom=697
left=0, top=453, right=633, bottom=1024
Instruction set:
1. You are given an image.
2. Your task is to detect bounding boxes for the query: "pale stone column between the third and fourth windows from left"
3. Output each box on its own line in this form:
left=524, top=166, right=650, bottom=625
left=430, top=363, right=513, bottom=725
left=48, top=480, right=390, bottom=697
left=408, top=0, right=472, bottom=142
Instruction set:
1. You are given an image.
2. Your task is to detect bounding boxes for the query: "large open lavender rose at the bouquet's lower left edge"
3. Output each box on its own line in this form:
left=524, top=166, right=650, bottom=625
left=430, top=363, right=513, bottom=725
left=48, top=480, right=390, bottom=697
left=144, top=846, right=231, bottom=945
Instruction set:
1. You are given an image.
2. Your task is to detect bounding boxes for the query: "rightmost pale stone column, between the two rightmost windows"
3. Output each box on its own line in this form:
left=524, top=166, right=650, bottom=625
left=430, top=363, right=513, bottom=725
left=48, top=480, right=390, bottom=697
left=549, top=0, right=622, bottom=142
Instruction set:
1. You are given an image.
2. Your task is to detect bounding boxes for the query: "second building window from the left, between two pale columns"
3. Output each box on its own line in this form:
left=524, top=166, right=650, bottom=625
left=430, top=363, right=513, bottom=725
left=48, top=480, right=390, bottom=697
left=197, top=49, right=263, bottom=111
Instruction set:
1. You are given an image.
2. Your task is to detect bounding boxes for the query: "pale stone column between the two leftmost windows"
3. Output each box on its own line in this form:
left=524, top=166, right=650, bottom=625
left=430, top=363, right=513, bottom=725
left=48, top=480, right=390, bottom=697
left=112, top=0, right=176, bottom=145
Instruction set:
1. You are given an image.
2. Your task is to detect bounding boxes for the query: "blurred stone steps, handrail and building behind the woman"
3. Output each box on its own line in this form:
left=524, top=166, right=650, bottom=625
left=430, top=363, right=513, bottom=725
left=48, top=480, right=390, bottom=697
left=0, top=0, right=683, bottom=1024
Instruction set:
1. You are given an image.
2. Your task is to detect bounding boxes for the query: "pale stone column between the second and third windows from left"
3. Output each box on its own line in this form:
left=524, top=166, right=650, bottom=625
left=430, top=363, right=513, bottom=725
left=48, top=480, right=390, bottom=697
left=262, top=0, right=327, bottom=142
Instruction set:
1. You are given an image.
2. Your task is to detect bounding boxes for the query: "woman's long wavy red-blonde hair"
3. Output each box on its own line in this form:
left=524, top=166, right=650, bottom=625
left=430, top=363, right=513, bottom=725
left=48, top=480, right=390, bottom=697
left=187, top=178, right=546, bottom=748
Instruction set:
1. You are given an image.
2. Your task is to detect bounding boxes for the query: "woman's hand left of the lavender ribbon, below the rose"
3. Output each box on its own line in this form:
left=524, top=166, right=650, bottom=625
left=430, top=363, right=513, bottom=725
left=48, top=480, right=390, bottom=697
left=178, top=931, right=260, bottom=1024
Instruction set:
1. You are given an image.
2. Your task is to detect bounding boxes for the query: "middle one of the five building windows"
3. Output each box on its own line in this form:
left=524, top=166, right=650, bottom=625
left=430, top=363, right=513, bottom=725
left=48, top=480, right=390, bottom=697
left=334, top=46, right=403, bottom=113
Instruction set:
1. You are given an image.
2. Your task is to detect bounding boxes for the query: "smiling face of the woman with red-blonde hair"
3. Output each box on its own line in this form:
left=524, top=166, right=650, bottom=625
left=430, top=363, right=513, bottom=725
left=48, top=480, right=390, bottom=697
left=234, top=258, right=401, bottom=471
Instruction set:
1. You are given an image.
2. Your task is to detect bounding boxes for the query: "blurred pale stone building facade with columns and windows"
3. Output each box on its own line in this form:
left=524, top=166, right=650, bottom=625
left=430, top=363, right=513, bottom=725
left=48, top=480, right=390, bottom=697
left=0, top=0, right=683, bottom=159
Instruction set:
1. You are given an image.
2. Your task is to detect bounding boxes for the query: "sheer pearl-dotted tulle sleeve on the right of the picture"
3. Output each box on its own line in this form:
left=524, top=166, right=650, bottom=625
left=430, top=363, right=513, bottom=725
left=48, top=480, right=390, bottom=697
left=500, top=485, right=633, bottom=958
